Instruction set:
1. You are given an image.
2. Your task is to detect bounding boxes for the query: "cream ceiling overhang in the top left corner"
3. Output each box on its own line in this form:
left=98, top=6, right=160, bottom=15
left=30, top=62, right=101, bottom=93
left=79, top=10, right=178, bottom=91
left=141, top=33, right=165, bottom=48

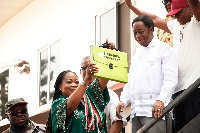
left=0, top=0, right=33, bottom=27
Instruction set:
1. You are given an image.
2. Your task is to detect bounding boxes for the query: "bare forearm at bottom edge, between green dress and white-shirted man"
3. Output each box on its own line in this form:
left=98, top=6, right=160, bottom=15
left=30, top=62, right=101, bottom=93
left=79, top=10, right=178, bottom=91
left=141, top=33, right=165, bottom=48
left=109, top=120, right=123, bottom=133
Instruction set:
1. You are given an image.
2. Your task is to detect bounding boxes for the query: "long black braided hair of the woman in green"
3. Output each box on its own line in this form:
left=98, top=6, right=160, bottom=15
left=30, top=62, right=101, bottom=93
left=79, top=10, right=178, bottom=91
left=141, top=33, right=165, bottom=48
left=46, top=70, right=76, bottom=133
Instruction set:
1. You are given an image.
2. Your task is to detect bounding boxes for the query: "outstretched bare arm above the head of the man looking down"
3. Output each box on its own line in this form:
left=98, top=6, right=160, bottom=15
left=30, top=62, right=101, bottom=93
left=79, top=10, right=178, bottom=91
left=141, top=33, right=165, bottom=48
left=125, top=0, right=171, bottom=33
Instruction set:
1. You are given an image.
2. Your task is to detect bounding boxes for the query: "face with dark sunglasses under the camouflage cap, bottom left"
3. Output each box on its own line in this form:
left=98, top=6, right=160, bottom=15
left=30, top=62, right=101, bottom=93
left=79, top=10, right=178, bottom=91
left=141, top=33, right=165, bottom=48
left=7, top=103, right=29, bottom=129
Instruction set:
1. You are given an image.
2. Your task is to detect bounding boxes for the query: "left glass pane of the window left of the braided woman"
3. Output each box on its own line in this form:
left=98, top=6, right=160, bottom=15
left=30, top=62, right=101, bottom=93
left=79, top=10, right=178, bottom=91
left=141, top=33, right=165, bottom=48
left=39, top=49, right=48, bottom=106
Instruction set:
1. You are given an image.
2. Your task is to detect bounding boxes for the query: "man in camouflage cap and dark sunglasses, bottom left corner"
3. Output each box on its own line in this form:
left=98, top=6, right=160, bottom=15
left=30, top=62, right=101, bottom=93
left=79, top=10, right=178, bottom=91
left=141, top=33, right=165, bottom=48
left=3, top=98, right=45, bottom=133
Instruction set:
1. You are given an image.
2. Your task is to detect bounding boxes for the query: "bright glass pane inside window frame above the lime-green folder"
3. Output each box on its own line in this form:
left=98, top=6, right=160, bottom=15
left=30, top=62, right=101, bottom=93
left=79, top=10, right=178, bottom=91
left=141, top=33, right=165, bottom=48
left=100, top=8, right=116, bottom=44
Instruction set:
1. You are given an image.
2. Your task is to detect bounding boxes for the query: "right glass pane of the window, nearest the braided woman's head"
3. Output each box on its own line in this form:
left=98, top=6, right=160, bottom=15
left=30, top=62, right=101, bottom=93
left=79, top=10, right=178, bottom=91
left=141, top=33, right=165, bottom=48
left=49, top=40, right=60, bottom=101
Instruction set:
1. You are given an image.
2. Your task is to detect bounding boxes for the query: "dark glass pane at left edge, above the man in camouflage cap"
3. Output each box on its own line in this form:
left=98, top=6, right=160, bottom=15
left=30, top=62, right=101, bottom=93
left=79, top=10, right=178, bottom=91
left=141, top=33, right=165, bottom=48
left=0, top=70, right=9, bottom=120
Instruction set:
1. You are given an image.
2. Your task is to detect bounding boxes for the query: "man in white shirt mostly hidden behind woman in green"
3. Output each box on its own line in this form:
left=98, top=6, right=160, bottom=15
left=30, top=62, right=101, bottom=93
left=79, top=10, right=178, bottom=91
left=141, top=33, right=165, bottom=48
left=80, top=56, right=127, bottom=133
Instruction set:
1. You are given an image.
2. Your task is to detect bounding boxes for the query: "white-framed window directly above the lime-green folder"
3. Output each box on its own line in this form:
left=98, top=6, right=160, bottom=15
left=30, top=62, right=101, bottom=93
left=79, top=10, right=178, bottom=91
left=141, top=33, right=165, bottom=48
left=95, top=2, right=118, bottom=47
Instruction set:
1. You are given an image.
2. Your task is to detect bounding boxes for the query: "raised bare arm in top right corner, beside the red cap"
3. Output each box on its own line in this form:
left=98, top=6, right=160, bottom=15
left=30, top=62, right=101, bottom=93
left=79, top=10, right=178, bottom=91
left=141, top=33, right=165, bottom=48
left=188, top=0, right=200, bottom=21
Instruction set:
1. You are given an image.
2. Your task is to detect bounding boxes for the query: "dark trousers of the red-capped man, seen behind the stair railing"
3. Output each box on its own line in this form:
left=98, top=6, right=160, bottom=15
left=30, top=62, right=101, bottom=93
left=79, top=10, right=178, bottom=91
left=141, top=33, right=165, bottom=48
left=172, top=88, right=200, bottom=133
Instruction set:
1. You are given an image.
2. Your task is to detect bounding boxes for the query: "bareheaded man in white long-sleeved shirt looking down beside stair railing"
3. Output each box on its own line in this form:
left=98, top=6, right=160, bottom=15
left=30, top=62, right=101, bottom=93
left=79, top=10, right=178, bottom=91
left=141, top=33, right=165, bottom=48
left=117, top=15, right=178, bottom=133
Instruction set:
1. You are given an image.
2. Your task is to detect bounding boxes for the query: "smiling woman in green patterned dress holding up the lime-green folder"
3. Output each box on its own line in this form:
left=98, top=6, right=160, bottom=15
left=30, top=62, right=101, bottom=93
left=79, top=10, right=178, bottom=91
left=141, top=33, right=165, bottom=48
left=46, top=64, right=110, bottom=133
